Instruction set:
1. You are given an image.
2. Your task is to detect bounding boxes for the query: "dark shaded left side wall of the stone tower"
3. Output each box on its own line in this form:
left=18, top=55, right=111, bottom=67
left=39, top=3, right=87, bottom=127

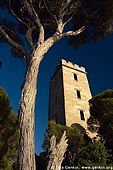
left=49, top=67, right=65, bottom=125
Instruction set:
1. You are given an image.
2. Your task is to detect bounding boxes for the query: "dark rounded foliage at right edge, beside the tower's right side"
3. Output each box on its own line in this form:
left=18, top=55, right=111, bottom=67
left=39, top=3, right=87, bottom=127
left=89, top=90, right=113, bottom=137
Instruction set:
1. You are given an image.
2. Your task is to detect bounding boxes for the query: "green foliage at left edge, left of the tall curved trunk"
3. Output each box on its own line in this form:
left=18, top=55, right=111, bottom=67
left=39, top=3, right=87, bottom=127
left=0, top=87, right=18, bottom=170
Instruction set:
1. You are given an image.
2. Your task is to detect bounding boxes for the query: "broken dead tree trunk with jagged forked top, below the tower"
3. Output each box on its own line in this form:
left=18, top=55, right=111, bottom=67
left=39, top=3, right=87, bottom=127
left=47, top=132, right=68, bottom=170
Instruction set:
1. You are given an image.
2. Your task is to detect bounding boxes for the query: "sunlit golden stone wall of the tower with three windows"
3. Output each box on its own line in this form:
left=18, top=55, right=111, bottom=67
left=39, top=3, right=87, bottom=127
left=62, top=60, right=92, bottom=129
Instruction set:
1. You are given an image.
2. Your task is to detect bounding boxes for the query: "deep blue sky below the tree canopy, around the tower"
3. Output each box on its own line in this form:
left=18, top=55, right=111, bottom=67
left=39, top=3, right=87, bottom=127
left=0, top=34, right=113, bottom=154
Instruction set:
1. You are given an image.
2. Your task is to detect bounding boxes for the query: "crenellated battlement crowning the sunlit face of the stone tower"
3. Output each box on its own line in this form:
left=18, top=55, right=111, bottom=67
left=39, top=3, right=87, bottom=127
left=61, top=59, right=86, bottom=73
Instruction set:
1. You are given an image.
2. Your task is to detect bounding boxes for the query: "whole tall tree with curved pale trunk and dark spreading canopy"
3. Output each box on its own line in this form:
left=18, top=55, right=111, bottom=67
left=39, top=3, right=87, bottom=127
left=0, top=0, right=113, bottom=170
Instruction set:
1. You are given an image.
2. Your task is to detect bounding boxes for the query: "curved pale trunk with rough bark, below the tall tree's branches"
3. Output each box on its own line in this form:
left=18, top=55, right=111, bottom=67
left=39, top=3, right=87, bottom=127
left=18, top=38, right=54, bottom=170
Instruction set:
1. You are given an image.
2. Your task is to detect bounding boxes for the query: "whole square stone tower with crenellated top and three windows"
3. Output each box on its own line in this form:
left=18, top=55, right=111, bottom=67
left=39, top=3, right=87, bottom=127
left=49, top=60, right=92, bottom=131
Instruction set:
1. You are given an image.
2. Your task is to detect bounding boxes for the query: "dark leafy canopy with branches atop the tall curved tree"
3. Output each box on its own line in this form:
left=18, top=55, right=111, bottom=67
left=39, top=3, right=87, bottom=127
left=0, top=0, right=113, bottom=63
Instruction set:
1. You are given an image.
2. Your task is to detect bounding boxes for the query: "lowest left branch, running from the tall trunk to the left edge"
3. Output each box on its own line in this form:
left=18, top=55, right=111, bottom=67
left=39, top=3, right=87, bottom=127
left=0, top=26, right=30, bottom=66
